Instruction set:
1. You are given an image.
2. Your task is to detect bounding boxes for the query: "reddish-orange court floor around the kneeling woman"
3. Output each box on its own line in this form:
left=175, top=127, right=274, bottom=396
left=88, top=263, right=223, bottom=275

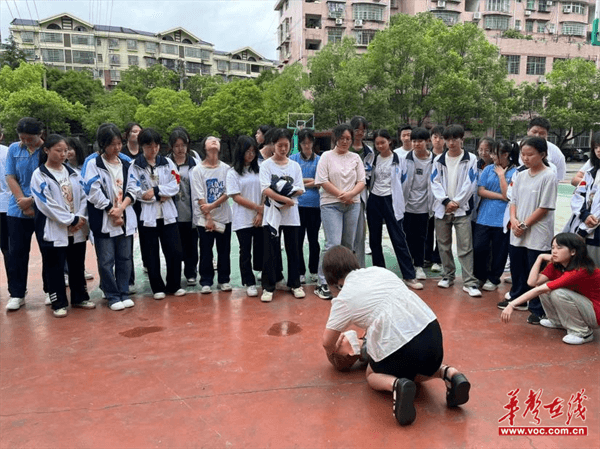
left=0, top=243, right=600, bottom=449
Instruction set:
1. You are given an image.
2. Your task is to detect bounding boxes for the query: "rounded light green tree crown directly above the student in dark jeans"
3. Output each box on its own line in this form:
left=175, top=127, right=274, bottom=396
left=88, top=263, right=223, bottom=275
left=83, top=89, right=139, bottom=139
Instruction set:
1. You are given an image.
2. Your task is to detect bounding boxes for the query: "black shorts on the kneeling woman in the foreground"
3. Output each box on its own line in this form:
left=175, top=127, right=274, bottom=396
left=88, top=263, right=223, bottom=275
left=370, top=320, right=444, bottom=380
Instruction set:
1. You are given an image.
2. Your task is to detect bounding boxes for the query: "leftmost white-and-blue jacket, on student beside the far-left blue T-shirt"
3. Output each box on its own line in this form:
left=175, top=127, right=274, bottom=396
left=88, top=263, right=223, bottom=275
left=30, top=165, right=89, bottom=247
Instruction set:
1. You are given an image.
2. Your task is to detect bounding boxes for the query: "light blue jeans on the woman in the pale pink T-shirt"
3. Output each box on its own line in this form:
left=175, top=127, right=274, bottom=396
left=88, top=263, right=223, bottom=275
left=319, top=203, right=364, bottom=285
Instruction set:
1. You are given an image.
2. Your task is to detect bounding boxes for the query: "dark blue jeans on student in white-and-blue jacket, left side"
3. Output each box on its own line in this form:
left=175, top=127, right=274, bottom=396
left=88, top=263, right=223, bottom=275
left=94, top=235, right=133, bottom=305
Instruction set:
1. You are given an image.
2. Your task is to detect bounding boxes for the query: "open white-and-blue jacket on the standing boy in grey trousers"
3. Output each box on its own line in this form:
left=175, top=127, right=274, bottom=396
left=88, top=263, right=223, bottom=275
left=431, top=150, right=477, bottom=219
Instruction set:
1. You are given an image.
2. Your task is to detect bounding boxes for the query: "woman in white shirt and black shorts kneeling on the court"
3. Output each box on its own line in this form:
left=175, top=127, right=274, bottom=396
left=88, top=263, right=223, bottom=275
left=323, top=246, right=471, bottom=425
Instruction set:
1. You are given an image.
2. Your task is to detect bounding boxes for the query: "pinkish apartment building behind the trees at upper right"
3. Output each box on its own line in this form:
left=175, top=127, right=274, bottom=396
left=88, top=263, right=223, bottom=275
left=275, top=0, right=600, bottom=83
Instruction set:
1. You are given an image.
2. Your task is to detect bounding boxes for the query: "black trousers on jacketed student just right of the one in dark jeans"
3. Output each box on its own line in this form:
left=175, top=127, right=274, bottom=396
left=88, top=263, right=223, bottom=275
left=138, top=218, right=182, bottom=293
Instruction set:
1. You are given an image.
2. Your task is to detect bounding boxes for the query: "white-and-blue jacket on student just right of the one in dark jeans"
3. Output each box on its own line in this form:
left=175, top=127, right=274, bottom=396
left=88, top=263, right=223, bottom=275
left=129, top=154, right=180, bottom=228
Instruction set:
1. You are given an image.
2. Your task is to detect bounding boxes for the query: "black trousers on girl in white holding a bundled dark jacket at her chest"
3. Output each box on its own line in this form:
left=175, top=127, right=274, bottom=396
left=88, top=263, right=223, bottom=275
left=262, top=226, right=300, bottom=292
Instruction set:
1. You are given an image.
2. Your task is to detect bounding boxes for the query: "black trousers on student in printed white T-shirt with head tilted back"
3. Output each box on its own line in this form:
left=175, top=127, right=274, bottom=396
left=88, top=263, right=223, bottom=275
left=196, top=223, right=231, bottom=287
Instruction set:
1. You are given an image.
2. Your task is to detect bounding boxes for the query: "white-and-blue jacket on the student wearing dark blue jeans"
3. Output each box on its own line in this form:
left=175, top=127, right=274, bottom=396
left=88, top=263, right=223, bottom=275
left=83, top=154, right=137, bottom=238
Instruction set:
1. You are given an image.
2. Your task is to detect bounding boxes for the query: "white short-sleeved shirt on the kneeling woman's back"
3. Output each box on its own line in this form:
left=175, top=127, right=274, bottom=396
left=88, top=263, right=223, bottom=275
left=326, top=267, right=436, bottom=362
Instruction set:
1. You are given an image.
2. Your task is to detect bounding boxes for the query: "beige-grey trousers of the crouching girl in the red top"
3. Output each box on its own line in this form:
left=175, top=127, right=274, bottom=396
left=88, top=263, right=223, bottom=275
left=540, top=288, right=599, bottom=337
